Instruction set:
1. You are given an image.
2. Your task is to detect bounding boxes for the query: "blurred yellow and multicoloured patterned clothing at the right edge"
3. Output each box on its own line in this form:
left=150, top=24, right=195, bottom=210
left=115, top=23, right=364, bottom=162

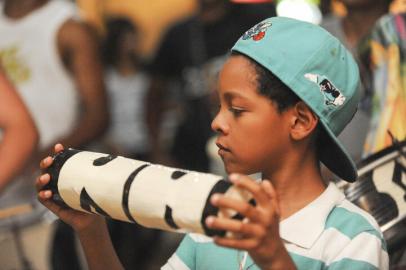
left=364, top=10, right=406, bottom=156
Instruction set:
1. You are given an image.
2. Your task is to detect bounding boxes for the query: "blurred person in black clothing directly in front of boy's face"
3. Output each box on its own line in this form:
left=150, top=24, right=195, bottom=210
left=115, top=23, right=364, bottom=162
left=146, top=0, right=275, bottom=172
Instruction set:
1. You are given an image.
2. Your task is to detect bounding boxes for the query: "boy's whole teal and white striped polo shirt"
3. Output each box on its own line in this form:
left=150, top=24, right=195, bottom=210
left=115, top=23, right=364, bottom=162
left=161, top=183, right=389, bottom=270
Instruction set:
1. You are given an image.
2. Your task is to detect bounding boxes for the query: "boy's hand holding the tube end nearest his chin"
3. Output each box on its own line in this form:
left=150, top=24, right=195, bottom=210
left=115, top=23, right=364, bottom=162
left=206, top=174, right=295, bottom=269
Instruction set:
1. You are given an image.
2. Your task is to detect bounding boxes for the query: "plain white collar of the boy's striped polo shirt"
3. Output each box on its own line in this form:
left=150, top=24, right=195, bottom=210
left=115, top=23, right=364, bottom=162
left=279, top=183, right=345, bottom=249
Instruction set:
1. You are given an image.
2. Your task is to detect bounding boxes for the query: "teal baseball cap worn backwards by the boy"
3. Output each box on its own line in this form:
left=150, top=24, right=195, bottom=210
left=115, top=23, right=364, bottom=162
left=231, top=17, right=360, bottom=182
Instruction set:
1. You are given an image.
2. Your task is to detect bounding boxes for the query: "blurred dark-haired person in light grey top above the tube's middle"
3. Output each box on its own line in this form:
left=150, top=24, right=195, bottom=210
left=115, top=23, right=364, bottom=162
left=103, top=17, right=149, bottom=160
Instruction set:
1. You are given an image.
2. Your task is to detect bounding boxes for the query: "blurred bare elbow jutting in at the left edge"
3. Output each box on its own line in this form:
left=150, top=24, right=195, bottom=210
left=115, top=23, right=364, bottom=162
left=0, top=67, right=38, bottom=193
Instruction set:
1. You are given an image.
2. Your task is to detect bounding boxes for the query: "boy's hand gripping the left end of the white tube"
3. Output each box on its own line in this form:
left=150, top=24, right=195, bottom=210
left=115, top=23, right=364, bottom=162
left=36, top=144, right=104, bottom=232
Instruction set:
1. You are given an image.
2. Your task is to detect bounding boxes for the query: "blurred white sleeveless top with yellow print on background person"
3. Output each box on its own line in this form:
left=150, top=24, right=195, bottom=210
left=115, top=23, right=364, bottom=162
left=0, top=0, right=78, bottom=149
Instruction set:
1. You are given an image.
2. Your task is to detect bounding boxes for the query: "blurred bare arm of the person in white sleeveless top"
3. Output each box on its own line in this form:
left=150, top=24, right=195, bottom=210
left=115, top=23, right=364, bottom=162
left=38, top=20, right=109, bottom=160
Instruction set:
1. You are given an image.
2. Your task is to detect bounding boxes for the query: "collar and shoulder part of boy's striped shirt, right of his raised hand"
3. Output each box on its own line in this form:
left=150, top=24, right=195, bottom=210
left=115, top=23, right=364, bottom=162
left=280, top=183, right=388, bottom=269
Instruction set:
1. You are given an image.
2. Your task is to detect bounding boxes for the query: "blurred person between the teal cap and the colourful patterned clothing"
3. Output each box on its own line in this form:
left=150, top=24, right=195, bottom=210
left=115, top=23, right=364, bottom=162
left=321, top=0, right=391, bottom=165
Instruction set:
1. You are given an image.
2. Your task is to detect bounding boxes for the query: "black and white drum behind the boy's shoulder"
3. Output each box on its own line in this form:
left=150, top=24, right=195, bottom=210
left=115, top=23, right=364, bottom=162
left=338, top=141, right=406, bottom=251
